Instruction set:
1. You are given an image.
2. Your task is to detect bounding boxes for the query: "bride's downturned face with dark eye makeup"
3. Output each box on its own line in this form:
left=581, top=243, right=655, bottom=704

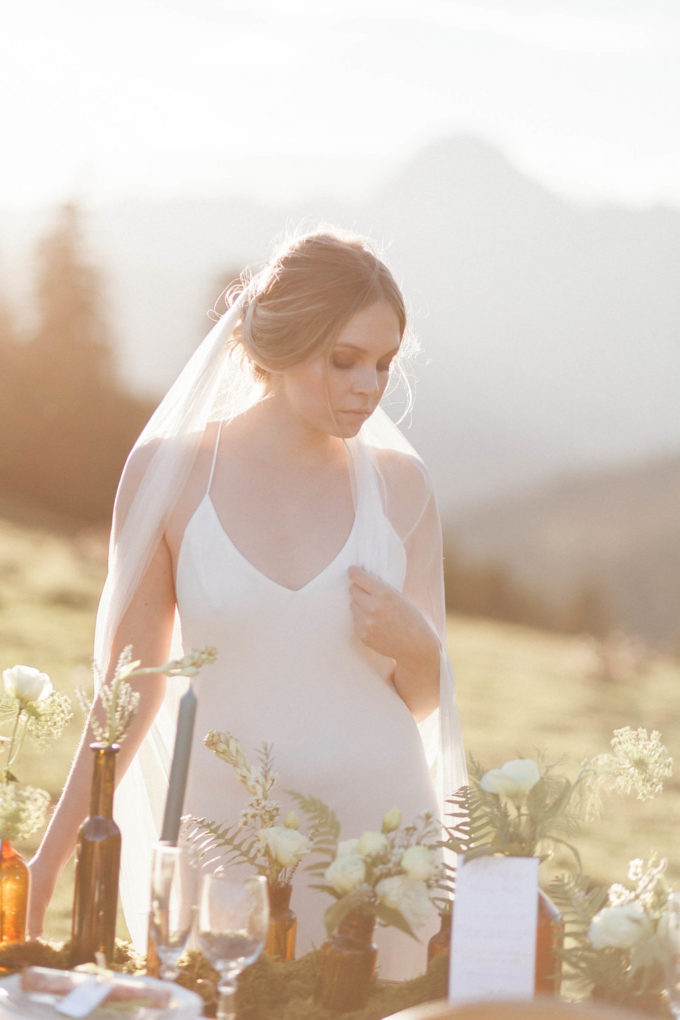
left=277, top=301, right=401, bottom=439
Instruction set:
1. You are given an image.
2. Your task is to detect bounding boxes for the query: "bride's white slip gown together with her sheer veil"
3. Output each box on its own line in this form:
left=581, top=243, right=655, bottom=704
left=102, top=299, right=466, bottom=978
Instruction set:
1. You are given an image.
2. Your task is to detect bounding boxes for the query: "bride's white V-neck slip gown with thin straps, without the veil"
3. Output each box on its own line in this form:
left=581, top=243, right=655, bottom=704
left=176, top=426, right=437, bottom=978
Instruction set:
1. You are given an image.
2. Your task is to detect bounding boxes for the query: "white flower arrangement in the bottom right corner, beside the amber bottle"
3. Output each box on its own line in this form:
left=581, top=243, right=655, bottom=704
left=550, top=859, right=670, bottom=1012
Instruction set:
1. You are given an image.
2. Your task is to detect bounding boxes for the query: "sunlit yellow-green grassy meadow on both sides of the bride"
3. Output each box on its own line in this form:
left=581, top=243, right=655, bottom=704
left=0, top=510, right=680, bottom=938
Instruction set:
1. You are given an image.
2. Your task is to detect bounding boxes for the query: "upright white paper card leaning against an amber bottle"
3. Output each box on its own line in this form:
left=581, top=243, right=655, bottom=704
left=449, top=857, right=538, bottom=1003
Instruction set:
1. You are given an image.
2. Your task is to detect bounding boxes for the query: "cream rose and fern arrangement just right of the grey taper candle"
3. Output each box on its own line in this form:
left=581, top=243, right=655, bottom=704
left=187, top=730, right=339, bottom=886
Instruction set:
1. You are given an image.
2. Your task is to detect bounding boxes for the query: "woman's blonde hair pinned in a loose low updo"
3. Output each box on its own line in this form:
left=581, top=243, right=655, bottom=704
left=229, top=230, right=407, bottom=378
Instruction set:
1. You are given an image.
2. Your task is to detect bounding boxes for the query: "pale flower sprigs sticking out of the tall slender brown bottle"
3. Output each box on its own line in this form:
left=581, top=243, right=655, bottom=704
left=77, top=645, right=217, bottom=747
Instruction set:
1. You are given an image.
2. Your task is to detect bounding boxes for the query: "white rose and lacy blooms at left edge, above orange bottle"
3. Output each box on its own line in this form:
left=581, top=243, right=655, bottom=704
left=0, top=666, right=72, bottom=840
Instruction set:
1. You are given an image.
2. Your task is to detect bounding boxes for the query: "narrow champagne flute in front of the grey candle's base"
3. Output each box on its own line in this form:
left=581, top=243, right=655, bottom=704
left=149, top=842, right=198, bottom=981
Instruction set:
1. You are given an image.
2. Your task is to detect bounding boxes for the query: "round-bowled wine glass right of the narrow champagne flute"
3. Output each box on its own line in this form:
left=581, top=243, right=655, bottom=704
left=198, top=868, right=269, bottom=1020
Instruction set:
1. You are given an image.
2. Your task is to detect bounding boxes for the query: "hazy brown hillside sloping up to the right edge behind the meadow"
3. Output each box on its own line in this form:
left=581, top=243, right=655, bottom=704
left=450, top=453, right=680, bottom=649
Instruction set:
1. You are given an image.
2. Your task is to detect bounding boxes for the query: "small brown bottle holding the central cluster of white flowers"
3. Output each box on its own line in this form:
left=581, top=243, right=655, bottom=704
left=314, top=910, right=378, bottom=1013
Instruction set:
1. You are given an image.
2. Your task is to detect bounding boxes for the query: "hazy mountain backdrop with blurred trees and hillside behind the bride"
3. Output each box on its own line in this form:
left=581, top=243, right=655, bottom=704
left=0, top=136, right=680, bottom=646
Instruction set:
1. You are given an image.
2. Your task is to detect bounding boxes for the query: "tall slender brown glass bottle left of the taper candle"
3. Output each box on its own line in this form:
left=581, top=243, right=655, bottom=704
left=71, top=744, right=120, bottom=966
